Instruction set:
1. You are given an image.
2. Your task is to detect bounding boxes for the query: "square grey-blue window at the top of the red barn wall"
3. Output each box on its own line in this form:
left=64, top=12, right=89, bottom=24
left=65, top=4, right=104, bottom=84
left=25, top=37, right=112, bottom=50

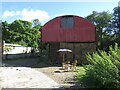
left=61, top=16, right=74, bottom=28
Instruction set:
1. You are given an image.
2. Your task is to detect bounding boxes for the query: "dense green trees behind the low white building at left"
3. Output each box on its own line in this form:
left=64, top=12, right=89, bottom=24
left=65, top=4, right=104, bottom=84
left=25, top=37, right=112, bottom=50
left=2, top=20, right=40, bottom=47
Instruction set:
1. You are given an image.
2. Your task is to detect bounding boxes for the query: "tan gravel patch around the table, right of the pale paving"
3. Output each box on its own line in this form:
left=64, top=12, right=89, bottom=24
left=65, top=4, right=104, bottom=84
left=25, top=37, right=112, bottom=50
left=33, top=67, right=84, bottom=88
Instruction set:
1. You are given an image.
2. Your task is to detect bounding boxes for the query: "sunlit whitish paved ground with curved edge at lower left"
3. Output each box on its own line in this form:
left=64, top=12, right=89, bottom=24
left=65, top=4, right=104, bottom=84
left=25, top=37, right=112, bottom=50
left=0, top=67, right=61, bottom=88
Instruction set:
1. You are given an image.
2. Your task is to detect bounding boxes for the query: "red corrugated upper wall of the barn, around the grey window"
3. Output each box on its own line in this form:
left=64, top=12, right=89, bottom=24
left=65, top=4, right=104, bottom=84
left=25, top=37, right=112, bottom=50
left=42, top=16, right=96, bottom=42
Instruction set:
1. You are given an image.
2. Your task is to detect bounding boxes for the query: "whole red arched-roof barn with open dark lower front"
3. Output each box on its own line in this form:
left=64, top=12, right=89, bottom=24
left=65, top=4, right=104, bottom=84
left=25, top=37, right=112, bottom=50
left=42, top=15, right=96, bottom=63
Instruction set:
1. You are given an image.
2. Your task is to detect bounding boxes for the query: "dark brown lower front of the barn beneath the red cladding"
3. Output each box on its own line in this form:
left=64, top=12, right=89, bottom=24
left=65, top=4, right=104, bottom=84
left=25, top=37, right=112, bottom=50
left=50, top=43, right=96, bottom=65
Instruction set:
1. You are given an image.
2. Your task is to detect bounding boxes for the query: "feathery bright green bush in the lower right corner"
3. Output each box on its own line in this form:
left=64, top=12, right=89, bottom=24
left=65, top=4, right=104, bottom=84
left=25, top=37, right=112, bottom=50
left=79, top=44, right=120, bottom=88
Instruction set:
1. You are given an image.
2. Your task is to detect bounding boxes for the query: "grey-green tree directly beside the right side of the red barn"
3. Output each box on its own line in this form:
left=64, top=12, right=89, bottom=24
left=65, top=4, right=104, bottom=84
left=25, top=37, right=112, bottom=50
left=86, top=11, right=112, bottom=49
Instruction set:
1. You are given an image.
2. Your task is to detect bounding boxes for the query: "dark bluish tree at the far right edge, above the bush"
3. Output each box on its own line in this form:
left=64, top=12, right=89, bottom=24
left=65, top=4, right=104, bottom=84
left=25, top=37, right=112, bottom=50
left=105, top=7, right=120, bottom=46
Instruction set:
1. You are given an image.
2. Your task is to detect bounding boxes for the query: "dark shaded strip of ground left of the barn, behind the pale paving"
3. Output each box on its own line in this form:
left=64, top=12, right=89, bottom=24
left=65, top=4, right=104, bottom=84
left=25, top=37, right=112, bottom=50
left=2, top=57, right=60, bottom=68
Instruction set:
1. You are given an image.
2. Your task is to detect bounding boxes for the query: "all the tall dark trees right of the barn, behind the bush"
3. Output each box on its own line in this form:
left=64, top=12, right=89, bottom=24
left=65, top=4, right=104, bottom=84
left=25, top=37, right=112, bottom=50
left=86, top=7, right=120, bottom=51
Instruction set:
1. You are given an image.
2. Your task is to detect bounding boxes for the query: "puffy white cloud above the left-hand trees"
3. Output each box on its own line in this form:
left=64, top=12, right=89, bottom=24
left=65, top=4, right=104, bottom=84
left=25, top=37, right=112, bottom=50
left=3, top=8, right=50, bottom=21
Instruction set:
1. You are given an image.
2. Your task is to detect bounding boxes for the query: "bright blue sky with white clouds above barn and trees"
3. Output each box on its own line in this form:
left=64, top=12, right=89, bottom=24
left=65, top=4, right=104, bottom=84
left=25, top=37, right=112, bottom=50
left=2, top=2, right=118, bottom=25
